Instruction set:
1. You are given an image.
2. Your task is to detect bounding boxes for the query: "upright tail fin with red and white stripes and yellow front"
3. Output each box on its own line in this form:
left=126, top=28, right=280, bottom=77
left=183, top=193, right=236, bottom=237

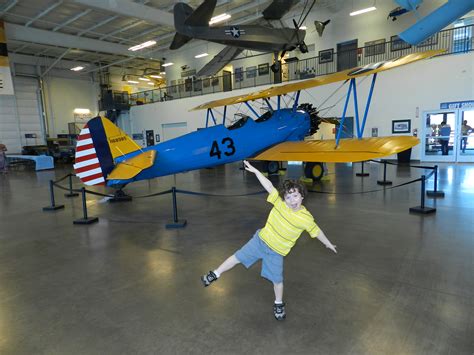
left=74, top=116, right=140, bottom=186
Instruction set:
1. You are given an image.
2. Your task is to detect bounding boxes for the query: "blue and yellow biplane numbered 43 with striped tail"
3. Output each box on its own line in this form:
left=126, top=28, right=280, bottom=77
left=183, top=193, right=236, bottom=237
left=74, top=50, right=443, bottom=191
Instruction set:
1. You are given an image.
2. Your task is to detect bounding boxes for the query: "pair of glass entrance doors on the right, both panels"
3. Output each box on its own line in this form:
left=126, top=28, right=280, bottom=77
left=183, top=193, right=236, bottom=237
left=421, top=109, right=474, bottom=163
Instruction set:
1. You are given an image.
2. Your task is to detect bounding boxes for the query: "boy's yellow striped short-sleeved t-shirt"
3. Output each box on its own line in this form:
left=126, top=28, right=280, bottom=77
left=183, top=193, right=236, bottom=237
left=259, top=189, right=319, bottom=256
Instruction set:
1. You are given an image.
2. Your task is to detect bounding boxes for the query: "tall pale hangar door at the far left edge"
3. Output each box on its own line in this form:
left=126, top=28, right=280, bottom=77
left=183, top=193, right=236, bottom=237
left=0, top=76, right=45, bottom=154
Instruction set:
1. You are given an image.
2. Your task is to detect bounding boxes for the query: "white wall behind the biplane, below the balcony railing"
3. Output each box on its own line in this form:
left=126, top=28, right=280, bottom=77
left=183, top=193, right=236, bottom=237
left=128, top=52, right=474, bottom=159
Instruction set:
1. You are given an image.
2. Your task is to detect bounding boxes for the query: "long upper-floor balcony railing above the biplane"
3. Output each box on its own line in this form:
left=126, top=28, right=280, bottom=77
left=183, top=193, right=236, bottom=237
left=130, top=25, right=474, bottom=106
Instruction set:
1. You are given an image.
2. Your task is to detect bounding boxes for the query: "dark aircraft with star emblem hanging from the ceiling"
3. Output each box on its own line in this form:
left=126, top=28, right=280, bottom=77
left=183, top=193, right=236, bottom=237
left=170, top=0, right=314, bottom=76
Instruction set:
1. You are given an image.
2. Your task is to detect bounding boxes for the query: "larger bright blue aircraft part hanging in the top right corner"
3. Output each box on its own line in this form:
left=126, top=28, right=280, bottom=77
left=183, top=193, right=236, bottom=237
left=399, top=0, right=474, bottom=45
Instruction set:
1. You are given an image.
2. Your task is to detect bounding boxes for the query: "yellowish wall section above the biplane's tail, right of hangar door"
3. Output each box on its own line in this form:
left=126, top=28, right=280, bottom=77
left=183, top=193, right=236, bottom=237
left=44, top=76, right=99, bottom=137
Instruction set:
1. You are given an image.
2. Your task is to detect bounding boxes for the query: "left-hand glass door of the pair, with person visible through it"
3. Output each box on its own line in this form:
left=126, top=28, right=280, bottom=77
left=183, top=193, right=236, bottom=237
left=421, top=110, right=458, bottom=162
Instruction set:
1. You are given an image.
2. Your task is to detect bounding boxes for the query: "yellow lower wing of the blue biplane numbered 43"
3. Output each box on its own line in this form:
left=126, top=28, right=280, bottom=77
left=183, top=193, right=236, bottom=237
left=252, top=136, right=420, bottom=163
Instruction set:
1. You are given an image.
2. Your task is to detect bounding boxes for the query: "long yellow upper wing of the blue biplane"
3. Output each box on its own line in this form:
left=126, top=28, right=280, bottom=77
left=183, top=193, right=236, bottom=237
left=191, top=49, right=446, bottom=111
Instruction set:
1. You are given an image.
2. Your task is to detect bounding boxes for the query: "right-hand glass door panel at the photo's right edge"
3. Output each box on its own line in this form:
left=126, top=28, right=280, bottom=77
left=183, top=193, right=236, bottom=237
left=456, top=109, right=474, bottom=162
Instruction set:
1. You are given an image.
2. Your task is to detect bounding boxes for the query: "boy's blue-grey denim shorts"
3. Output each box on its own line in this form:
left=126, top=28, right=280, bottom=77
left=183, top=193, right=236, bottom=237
left=235, top=229, right=283, bottom=283
